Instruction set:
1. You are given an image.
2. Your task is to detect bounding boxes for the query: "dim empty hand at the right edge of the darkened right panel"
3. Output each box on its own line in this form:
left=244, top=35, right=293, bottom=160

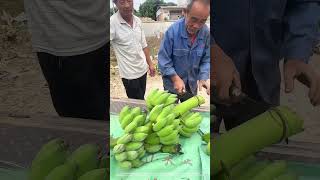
left=283, top=60, right=320, bottom=106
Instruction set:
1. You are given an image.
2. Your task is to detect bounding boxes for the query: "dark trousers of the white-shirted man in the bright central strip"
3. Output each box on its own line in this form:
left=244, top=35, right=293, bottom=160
left=122, top=73, right=147, bottom=100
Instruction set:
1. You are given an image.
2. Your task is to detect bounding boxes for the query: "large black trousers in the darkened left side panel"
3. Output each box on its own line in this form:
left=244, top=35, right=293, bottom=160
left=37, top=45, right=109, bottom=120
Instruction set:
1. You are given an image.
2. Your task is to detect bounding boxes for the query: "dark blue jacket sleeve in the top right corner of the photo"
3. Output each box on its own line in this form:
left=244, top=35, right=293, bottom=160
left=284, top=0, right=320, bottom=63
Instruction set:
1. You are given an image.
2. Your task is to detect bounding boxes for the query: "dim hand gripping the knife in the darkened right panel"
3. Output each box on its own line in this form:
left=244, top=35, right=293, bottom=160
left=211, top=45, right=241, bottom=102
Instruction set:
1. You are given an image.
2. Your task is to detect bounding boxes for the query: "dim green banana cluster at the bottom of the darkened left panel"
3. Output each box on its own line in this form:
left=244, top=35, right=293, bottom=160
left=28, top=138, right=108, bottom=180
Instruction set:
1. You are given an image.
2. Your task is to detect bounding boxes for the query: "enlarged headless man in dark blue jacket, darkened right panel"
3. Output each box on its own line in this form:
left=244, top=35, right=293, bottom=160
left=211, top=0, right=320, bottom=129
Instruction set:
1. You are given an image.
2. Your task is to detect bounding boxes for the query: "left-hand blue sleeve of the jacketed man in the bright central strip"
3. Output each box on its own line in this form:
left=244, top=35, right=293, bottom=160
left=158, top=28, right=177, bottom=76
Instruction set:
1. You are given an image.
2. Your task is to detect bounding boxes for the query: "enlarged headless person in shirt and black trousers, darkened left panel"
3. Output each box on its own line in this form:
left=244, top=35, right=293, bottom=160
left=24, top=0, right=109, bottom=120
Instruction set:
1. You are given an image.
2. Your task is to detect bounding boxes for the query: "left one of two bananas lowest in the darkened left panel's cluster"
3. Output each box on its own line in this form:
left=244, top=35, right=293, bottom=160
left=45, top=163, right=76, bottom=180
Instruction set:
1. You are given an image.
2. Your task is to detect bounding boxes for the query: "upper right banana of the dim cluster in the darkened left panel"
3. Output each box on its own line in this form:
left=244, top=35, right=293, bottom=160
left=68, top=144, right=101, bottom=177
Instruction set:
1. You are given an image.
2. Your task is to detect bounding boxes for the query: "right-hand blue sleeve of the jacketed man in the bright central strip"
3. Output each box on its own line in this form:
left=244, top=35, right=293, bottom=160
left=199, top=33, right=211, bottom=80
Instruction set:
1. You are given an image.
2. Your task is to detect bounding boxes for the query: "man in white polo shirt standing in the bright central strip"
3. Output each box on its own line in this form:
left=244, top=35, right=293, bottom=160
left=110, top=0, right=155, bottom=99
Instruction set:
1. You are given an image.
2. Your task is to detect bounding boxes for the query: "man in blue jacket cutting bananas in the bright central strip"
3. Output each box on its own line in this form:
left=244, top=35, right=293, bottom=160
left=158, top=0, right=210, bottom=101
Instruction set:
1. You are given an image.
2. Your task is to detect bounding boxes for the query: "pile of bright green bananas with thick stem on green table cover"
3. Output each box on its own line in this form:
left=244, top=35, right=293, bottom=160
left=110, top=89, right=208, bottom=169
